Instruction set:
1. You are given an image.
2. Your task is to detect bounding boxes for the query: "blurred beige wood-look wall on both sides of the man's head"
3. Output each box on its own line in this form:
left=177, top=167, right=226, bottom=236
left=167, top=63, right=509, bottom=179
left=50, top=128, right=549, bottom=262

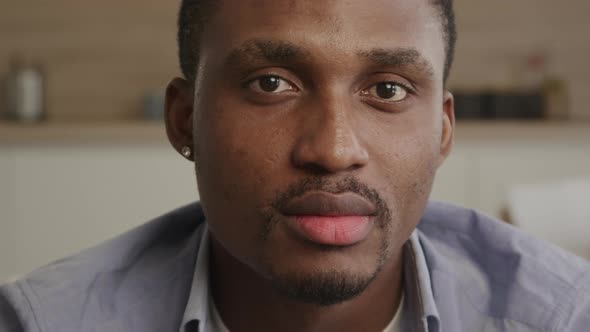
left=0, top=0, right=590, bottom=119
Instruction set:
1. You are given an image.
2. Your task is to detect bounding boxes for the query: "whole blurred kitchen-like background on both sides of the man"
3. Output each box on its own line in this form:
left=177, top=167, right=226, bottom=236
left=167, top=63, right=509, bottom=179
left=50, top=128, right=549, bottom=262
left=0, top=0, right=590, bottom=281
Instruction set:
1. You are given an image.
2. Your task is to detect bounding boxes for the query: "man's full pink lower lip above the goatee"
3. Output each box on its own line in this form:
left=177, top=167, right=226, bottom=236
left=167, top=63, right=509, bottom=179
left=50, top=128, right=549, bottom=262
left=291, top=216, right=371, bottom=246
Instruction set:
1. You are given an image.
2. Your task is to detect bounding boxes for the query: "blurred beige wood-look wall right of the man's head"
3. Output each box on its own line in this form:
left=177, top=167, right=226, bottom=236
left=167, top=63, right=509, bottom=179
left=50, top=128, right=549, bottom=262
left=450, top=0, right=590, bottom=119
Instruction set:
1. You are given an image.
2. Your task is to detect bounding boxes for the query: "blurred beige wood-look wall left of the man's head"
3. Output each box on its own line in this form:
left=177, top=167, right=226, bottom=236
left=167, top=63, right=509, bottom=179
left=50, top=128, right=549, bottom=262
left=0, top=0, right=178, bottom=120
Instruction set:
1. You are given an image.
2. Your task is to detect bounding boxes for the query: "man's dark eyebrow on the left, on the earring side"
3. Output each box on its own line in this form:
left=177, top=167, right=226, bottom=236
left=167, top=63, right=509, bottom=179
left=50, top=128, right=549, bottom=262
left=226, top=39, right=310, bottom=65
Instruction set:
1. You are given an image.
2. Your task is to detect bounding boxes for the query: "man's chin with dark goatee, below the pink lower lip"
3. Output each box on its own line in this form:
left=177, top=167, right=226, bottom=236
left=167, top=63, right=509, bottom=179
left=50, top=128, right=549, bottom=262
left=264, top=229, right=390, bottom=306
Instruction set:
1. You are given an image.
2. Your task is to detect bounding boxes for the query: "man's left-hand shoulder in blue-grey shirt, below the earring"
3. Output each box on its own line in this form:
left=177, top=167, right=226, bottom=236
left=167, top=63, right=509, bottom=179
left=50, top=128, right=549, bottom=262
left=0, top=203, right=204, bottom=331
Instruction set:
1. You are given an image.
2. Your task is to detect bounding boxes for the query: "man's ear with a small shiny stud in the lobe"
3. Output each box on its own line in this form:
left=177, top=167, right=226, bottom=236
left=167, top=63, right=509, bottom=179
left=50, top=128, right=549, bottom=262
left=164, top=78, right=194, bottom=160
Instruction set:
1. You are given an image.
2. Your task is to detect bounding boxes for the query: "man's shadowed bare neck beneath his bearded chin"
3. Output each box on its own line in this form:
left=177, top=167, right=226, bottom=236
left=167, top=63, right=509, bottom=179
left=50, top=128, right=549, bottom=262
left=210, top=237, right=403, bottom=332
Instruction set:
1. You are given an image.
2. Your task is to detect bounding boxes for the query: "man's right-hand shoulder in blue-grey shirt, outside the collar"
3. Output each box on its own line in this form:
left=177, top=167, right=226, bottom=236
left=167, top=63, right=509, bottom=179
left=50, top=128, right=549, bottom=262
left=418, top=202, right=590, bottom=331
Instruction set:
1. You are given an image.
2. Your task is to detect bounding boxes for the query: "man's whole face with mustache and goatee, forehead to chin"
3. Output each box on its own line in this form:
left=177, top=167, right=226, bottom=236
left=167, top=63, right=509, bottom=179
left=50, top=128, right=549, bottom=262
left=180, top=0, right=453, bottom=303
